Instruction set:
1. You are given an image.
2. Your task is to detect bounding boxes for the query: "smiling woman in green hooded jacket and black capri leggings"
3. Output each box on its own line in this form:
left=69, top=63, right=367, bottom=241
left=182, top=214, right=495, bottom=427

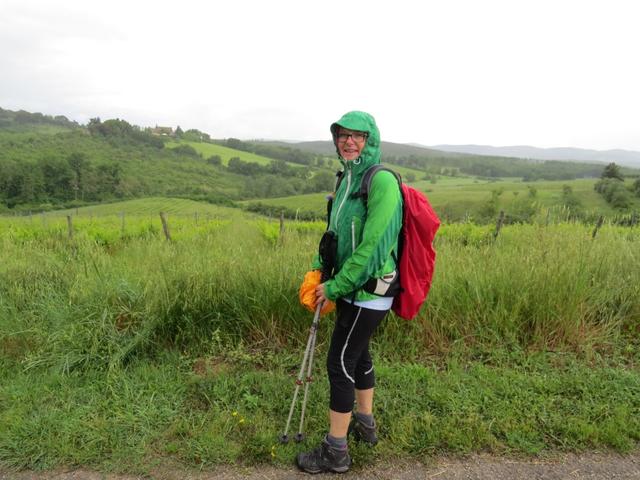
left=296, top=111, right=402, bottom=473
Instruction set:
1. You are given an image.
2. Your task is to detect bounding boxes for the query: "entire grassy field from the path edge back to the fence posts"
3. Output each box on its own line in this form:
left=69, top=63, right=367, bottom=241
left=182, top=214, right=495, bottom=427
left=0, top=201, right=640, bottom=473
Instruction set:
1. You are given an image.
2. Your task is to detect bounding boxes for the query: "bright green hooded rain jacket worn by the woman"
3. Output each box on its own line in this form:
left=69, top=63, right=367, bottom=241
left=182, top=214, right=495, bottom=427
left=312, top=111, right=402, bottom=301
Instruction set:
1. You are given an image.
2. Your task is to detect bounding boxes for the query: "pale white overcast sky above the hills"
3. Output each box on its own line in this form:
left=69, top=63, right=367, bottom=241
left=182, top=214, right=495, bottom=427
left=0, top=0, right=640, bottom=150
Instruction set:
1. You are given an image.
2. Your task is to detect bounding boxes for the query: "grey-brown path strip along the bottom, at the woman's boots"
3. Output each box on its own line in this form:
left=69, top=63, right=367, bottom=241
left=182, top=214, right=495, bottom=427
left=0, top=452, right=640, bottom=480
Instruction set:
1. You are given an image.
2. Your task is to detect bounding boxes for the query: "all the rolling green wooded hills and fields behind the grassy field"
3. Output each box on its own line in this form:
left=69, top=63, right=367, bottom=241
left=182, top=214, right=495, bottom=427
left=0, top=109, right=640, bottom=220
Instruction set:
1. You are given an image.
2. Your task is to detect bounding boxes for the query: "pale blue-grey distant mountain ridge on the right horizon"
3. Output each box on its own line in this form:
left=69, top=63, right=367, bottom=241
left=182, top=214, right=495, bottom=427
left=430, top=145, right=640, bottom=168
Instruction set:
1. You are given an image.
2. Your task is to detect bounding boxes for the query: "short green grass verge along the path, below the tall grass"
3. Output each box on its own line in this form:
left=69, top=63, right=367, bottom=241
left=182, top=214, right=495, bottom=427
left=0, top=345, right=640, bottom=474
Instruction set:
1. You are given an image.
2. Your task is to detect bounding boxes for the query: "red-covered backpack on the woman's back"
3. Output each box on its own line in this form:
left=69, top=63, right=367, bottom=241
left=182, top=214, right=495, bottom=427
left=359, top=164, right=440, bottom=320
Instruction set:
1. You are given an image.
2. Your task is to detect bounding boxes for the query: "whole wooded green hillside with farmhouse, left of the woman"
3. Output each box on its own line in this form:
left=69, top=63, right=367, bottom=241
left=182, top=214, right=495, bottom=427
left=0, top=110, right=334, bottom=212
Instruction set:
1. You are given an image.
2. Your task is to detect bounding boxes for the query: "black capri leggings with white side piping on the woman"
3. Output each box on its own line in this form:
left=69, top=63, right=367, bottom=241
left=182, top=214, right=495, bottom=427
left=327, top=300, right=388, bottom=413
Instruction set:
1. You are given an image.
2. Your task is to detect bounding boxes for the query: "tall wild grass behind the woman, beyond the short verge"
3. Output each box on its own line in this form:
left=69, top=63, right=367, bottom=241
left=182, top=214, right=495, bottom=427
left=0, top=213, right=640, bottom=370
